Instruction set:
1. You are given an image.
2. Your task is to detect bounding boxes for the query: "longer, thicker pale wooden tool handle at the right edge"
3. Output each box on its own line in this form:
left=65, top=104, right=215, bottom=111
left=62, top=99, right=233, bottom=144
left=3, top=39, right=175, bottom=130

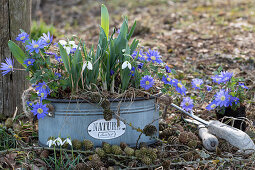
left=208, top=120, right=255, bottom=154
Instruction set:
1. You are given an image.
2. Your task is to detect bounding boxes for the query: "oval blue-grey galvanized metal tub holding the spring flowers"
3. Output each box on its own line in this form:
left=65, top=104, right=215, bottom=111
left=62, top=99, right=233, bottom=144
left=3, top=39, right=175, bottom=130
left=39, top=98, right=159, bottom=146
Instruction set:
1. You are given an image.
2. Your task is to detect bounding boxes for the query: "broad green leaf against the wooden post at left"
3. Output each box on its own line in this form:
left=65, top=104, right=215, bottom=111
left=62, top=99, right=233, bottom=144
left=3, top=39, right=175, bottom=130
left=8, top=40, right=27, bottom=68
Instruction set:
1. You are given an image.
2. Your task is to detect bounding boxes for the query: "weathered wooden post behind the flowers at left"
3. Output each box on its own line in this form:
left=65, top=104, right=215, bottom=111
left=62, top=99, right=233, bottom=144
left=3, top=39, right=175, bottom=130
left=0, top=0, right=32, bottom=116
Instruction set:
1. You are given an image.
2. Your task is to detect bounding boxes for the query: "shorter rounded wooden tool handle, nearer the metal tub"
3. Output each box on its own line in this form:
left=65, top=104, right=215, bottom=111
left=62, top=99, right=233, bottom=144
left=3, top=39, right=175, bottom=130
left=198, top=124, right=219, bottom=151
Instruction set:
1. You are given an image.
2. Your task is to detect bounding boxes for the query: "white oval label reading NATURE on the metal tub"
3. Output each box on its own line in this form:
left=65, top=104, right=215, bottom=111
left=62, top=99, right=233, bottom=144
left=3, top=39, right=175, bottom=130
left=88, top=119, right=126, bottom=139
